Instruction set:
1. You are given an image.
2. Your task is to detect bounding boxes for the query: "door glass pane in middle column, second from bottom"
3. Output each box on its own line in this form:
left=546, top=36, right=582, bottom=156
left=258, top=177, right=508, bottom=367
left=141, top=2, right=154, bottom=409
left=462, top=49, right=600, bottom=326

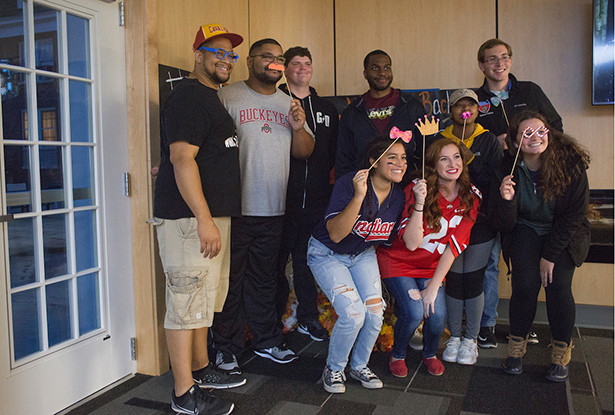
left=43, top=215, right=68, bottom=279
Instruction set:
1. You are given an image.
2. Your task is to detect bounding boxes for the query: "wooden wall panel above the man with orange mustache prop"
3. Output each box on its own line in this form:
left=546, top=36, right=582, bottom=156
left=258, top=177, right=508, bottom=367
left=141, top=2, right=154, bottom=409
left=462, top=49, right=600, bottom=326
left=249, top=0, right=335, bottom=96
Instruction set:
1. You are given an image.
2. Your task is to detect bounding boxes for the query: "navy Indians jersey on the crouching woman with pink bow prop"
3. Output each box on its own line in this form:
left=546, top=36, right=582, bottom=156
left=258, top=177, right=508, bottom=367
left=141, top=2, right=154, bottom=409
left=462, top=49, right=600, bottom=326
left=312, top=171, right=405, bottom=255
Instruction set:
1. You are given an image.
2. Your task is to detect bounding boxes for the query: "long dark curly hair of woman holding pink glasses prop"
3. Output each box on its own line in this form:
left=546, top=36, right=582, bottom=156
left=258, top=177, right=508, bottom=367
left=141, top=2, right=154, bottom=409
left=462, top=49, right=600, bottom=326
left=506, top=111, right=590, bottom=200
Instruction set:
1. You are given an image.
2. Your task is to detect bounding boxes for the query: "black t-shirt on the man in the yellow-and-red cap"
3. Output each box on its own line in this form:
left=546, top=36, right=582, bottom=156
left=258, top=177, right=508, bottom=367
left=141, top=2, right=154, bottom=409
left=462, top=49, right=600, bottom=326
left=154, top=79, right=241, bottom=219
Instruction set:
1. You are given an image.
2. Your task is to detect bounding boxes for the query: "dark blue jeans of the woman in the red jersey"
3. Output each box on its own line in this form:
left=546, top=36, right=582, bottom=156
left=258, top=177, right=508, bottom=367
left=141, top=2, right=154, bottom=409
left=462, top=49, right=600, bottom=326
left=383, top=277, right=446, bottom=359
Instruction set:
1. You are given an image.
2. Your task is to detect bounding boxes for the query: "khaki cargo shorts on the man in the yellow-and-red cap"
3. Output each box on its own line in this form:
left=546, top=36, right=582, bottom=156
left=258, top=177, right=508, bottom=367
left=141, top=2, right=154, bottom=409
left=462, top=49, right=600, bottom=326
left=151, top=217, right=231, bottom=330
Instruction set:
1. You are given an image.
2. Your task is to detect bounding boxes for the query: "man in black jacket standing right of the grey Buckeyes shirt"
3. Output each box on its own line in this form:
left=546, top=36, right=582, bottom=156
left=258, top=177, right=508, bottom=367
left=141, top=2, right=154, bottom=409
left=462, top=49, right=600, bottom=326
left=277, top=46, right=339, bottom=341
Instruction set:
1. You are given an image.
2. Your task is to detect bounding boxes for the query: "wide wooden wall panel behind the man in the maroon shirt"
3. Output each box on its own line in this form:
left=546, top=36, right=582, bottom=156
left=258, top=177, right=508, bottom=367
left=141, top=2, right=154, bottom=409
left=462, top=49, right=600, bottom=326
left=335, top=0, right=495, bottom=95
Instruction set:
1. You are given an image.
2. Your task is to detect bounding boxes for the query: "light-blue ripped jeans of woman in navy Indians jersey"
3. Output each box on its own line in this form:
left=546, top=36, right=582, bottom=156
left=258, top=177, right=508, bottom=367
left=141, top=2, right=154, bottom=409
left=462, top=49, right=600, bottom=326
left=307, top=238, right=384, bottom=371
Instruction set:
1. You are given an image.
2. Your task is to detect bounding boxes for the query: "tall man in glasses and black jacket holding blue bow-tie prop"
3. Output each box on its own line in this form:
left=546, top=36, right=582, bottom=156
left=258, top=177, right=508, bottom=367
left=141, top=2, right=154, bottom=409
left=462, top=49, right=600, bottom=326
left=476, top=39, right=563, bottom=348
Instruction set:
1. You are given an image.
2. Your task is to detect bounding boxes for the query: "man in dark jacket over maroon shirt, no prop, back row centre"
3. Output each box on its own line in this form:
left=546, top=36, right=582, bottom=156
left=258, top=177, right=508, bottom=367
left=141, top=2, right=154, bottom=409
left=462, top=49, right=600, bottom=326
left=335, top=50, right=425, bottom=183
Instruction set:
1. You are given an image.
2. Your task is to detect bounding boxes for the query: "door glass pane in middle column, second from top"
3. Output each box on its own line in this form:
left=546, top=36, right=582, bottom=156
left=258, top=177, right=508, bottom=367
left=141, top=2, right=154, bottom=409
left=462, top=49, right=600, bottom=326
left=32, top=76, right=62, bottom=141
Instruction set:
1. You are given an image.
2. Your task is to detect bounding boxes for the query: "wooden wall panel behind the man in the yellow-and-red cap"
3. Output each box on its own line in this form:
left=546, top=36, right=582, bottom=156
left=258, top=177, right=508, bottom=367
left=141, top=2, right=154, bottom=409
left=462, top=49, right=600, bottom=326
left=156, top=0, right=250, bottom=82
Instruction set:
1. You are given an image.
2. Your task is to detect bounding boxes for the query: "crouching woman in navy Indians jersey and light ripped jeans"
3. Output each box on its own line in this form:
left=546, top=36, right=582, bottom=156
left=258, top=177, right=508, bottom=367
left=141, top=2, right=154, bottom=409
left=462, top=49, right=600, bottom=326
left=307, top=137, right=407, bottom=393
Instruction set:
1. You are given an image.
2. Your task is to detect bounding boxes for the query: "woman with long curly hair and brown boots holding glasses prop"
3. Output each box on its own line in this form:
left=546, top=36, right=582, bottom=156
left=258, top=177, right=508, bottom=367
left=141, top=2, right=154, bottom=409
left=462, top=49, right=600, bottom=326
left=490, top=111, right=589, bottom=382
